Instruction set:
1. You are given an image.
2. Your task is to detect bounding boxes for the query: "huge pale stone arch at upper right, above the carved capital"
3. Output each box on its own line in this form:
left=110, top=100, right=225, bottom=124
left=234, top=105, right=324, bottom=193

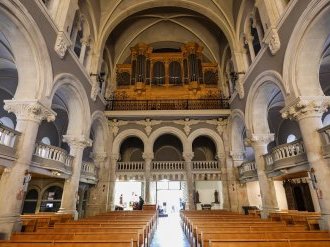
left=283, top=0, right=330, bottom=99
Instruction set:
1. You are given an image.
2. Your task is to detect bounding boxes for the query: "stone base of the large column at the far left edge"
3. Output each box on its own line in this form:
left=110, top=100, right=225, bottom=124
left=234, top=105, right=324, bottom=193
left=0, top=215, right=22, bottom=240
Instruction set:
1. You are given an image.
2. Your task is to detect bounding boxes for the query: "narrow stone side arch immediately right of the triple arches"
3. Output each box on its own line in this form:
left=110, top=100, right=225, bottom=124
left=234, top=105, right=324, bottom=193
left=229, top=109, right=245, bottom=153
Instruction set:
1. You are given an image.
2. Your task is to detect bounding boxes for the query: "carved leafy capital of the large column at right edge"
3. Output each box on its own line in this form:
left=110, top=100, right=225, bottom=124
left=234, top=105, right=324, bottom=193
left=281, top=96, right=330, bottom=121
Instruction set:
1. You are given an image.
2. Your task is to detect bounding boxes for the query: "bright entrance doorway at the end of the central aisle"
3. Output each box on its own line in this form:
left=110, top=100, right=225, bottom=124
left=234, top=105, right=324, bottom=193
left=156, top=181, right=185, bottom=216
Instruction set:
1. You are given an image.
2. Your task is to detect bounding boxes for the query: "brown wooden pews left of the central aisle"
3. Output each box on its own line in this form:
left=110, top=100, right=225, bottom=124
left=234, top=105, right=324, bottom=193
left=0, top=210, right=157, bottom=247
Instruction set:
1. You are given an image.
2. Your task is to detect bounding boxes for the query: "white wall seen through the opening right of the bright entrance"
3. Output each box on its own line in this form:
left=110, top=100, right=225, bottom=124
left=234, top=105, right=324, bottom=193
left=195, top=181, right=223, bottom=208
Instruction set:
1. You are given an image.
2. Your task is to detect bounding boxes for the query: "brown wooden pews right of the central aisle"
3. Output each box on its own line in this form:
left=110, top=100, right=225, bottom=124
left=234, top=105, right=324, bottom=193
left=180, top=210, right=330, bottom=247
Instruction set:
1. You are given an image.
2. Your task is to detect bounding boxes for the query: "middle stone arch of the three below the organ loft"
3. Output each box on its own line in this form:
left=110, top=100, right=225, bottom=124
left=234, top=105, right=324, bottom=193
left=145, top=126, right=187, bottom=153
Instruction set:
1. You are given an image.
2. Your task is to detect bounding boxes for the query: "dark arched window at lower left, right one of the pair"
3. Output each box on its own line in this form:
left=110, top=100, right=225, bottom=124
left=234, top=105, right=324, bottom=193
left=40, top=186, right=62, bottom=212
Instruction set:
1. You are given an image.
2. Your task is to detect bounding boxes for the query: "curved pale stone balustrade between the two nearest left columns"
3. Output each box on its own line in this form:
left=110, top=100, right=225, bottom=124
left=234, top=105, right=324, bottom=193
left=34, top=143, right=73, bottom=168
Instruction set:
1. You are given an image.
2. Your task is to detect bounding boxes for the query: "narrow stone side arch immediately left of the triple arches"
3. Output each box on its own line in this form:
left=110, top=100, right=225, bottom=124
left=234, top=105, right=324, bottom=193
left=90, top=111, right=110, bottom=153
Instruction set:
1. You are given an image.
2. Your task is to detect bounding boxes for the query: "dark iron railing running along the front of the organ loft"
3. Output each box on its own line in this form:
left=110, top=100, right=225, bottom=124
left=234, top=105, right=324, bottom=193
left=106, top=99, right=229, bottom=111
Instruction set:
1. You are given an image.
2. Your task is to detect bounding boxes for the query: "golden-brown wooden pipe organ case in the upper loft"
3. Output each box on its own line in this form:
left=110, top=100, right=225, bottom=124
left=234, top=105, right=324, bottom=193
left=115, top=42, right=219, bottom=100
